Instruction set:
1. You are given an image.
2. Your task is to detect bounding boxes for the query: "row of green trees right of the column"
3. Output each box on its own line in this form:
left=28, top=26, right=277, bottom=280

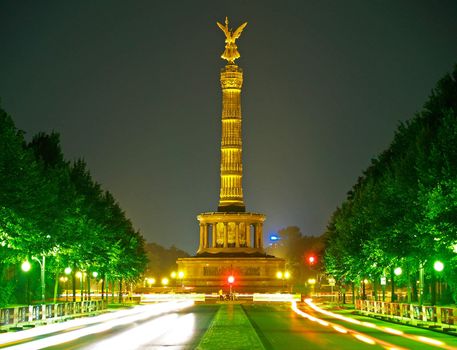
left=325, top=66, right=457, bottom=302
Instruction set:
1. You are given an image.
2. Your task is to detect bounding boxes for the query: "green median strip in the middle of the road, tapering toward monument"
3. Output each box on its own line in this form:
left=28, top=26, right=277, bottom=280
left=196, top=304, right=265, bottom=350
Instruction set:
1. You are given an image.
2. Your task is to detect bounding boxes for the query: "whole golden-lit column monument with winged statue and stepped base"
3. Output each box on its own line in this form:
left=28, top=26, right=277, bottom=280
left=177, top=19, right=285, bottom=292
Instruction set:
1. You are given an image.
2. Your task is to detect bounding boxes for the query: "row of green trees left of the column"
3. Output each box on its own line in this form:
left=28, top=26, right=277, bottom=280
left=0, top=105, right=147, bottom=305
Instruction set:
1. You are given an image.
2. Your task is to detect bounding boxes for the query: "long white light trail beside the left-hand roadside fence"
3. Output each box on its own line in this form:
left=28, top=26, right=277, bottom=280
left=0, top=300, right=194, bottom=350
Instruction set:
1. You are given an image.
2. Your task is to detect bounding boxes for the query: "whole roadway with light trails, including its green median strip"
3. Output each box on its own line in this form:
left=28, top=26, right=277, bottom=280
left=0, top=302, right=457, bottom=350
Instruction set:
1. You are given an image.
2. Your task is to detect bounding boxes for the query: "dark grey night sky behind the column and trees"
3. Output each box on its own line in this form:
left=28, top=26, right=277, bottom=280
left=0, top=0, right=457, bottom=254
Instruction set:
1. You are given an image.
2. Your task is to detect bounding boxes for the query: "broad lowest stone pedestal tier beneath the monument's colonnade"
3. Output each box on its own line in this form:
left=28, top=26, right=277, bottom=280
left=177, top=256, right=288, bottom=294
